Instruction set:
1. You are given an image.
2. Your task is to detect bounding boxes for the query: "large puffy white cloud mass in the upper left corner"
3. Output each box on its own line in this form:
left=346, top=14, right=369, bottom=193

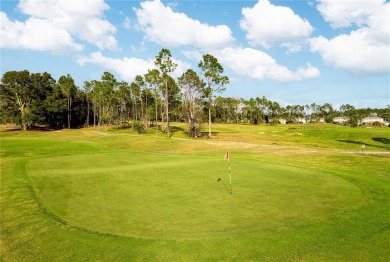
left=1, top=0, right=117, bottom=53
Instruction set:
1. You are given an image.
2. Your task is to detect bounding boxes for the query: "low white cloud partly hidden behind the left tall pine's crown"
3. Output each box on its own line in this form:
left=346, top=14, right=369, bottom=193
left=77, top=52, right=190, bottom=82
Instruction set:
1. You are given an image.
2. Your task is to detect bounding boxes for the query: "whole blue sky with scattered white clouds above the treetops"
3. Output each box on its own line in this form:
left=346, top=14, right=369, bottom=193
left=0, top=0, right=390, bottom=108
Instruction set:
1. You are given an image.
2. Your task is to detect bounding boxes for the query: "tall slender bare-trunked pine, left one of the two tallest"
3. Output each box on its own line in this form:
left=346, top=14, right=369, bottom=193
left=154, top=49, right=177, bottom=137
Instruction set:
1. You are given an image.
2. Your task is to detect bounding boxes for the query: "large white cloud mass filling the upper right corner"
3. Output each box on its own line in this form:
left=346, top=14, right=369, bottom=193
left=309, top=0, right=390, bottom=75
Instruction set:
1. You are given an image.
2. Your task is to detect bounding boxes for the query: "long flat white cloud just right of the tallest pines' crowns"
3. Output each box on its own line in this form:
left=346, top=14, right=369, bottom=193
left=218, top=48, right=320, bottom=82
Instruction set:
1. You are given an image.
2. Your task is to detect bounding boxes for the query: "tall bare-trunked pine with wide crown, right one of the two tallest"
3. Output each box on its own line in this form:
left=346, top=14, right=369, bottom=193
left=198, top=54, right=229, bottom=138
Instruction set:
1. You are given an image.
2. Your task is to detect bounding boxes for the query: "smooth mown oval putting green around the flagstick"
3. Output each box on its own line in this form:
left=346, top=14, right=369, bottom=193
left=26, top=152, right=362, bottom=239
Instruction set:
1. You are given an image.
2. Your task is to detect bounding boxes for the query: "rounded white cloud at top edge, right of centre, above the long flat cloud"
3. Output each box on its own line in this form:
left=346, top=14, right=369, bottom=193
left=240, top=0, right=313, bottom=51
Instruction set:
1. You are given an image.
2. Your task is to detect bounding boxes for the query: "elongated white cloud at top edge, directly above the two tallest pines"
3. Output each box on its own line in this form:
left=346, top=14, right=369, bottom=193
left=134, top=0, right=234, bottom=48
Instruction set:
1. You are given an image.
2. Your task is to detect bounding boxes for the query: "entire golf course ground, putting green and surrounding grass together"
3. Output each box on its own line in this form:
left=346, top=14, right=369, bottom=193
left=0, top=123, right=390, bottom=261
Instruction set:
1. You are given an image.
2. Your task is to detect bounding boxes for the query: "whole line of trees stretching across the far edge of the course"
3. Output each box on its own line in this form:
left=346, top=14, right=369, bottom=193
left=0, top=49, right=390, bottom=137
